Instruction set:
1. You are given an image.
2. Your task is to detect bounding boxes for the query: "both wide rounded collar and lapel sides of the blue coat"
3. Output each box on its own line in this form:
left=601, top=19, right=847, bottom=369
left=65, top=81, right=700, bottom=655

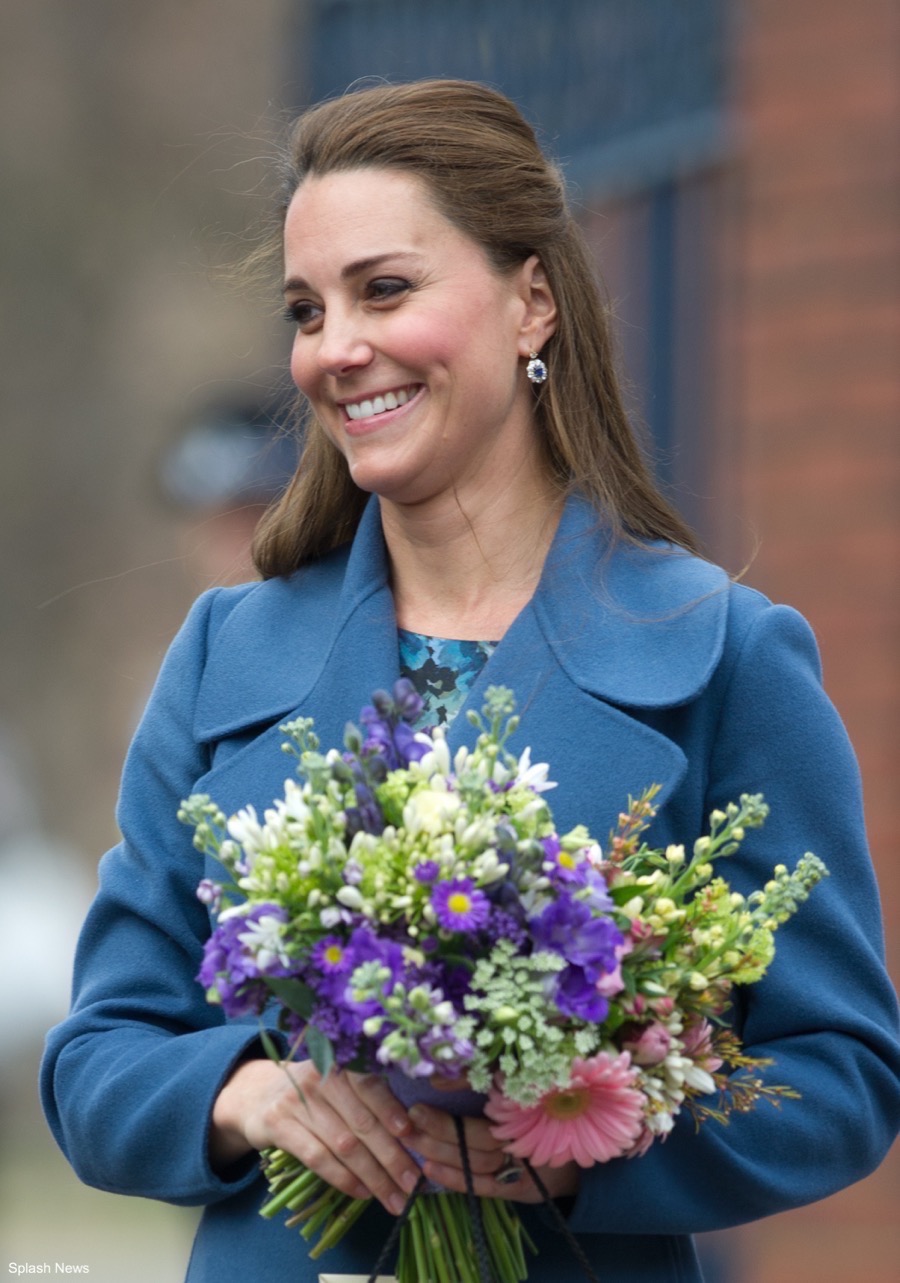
left=195, top=497, right=728, bottom=822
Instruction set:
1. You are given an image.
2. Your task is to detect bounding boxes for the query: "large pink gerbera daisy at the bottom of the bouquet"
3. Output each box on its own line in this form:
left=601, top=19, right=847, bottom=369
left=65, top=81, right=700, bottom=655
left=484, top=1052, right=643, bottom=1168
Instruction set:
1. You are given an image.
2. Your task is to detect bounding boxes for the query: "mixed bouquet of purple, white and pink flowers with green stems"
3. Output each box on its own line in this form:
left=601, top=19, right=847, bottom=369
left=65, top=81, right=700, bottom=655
left=178, top=680, right=827, bottom=1283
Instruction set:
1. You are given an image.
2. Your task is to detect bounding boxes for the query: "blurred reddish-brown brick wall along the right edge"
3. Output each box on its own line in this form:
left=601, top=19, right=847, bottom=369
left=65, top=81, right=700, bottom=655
left=719, top=0, right=900, bottom=1283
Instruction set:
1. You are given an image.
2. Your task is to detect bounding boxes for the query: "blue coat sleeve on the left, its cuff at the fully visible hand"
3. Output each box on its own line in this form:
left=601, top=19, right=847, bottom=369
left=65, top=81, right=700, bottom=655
left=41, top=589, right=277, bottom=1205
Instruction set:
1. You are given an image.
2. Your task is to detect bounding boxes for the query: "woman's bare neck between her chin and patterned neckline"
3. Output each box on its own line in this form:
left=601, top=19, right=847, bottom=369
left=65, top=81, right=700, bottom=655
left=381, top=479, right=562, bottom=640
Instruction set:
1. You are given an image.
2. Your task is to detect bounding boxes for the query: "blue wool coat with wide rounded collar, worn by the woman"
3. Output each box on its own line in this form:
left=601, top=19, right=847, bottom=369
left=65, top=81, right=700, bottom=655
left=42, top=498, right=900, bottom=1283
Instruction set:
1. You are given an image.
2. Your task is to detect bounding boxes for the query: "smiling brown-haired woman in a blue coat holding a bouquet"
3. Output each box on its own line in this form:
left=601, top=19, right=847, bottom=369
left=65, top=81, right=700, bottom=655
left=42, top=82, right=900, bottom=1283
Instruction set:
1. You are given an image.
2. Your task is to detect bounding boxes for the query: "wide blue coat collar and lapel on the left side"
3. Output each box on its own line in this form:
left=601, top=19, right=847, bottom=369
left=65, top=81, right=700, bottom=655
left=194, top=503, right=399, bottom=813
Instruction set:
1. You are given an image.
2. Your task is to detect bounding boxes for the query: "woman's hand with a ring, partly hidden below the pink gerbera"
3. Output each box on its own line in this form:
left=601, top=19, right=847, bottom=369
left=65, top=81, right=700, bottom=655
left=408, top=1105, right=579, bottom=1203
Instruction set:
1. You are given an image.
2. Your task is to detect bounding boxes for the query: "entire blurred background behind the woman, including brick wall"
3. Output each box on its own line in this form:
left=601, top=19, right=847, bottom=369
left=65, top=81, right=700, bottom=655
left=0, top=0, right=900, bottom=1283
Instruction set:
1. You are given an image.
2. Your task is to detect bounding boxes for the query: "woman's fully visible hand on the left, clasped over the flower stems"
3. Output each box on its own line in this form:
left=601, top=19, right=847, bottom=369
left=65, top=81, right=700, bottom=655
left=209, top=1060, right=421, bottom=1215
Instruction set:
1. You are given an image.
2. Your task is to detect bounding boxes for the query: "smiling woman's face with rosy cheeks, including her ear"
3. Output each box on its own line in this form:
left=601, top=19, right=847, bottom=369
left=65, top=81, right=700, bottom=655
left=285, top=169, right=555, bottom=503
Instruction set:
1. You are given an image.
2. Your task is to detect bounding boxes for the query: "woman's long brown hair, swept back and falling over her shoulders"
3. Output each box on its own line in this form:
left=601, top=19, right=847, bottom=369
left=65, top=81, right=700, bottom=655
left=253, top=80, right=696, bottom=579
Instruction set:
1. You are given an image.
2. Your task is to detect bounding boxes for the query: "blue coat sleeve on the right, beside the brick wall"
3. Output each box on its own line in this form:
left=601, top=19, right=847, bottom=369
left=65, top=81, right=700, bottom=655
left=571, top=604, right=900, bottom=1233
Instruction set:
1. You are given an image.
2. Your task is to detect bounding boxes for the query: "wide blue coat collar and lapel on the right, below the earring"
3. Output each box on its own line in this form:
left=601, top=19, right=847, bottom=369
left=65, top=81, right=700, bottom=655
left=441, top=497, right=728, bottom=838
